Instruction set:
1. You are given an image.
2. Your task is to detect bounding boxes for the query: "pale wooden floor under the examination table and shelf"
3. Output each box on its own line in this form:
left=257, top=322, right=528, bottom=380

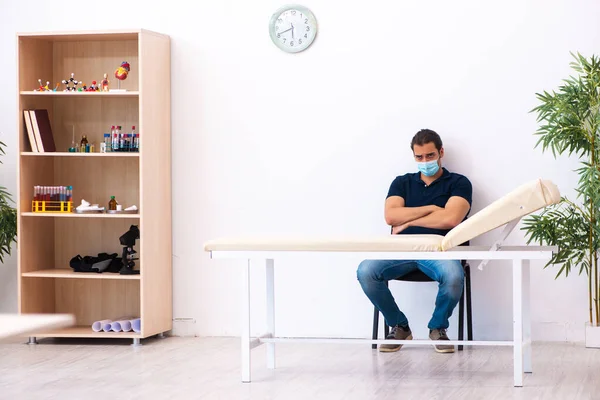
left=0, top=337, right=600, bottom=400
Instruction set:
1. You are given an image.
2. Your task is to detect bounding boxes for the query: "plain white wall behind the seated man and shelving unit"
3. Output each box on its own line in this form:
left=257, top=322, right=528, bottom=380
left=0, top=0, right=600, bottom=341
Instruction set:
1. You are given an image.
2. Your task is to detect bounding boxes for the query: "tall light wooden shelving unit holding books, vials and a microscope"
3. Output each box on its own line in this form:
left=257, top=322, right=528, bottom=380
left=17, top=29, right=172, bottom=343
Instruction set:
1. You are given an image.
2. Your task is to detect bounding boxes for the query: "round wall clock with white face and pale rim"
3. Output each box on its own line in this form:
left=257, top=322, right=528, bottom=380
left=269, top=5, right=317, bottom=53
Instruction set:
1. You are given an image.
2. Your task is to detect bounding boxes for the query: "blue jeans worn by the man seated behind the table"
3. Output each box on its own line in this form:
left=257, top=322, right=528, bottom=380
left=356, top=260, right=464, bottom=329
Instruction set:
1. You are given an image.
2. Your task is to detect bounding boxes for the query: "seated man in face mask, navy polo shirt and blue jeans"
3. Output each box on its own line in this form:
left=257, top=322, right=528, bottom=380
left=357, top=129, right=473, bottom=353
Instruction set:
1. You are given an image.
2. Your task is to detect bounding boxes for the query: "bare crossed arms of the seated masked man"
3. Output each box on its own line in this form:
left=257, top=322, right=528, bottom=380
left=385, top=196, right=470, bottom=234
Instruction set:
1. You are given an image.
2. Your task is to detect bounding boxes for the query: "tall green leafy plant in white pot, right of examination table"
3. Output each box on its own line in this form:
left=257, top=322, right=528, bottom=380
left=522, top=53, right=600, bottom=347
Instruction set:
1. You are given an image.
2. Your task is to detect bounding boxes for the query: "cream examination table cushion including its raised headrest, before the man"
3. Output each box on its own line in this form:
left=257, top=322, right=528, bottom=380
left=204, top=179, right=560, bottom=252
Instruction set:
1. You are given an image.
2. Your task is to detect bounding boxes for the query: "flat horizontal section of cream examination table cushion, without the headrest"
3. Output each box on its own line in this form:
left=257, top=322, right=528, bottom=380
left=204, top=235, right=443, bottom=252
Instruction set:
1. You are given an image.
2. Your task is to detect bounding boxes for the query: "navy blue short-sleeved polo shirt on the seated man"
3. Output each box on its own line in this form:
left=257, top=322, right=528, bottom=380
left=387, top=168, right=473, bottom=235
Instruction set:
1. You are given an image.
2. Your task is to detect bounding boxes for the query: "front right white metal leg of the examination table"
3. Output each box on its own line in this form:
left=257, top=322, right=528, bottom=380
left=513, top=260, right=523, bottom=386
